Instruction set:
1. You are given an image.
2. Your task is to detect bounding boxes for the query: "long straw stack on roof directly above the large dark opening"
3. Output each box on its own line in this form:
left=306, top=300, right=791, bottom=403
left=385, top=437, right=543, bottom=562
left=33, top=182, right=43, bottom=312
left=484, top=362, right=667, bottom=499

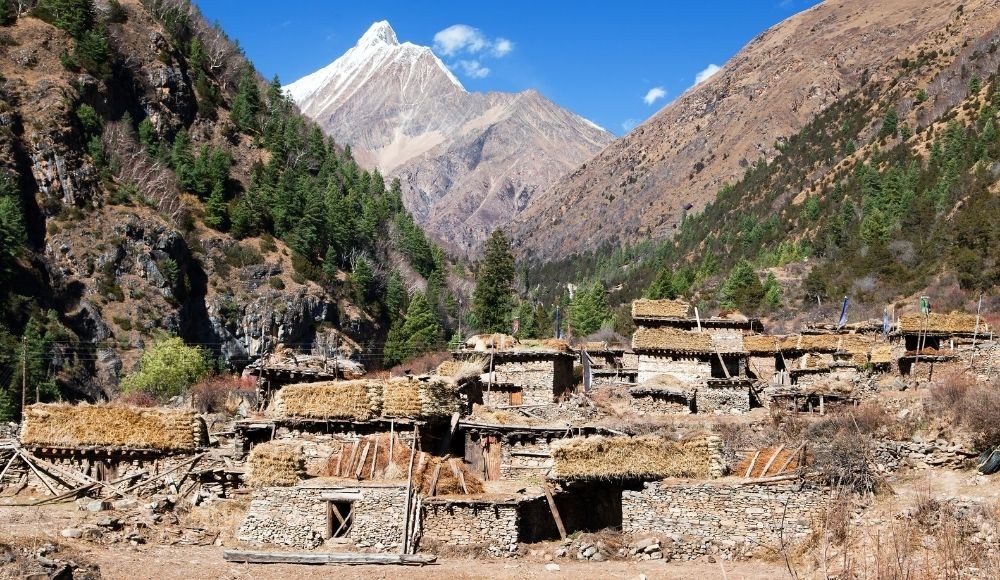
left=552, top=435, right=712, bottom=479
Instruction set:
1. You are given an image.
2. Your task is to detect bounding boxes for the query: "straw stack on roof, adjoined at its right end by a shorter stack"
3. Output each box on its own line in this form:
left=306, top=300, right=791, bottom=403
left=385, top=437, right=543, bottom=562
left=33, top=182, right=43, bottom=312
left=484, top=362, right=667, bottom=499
left=273, top=380, right=382, bottom=421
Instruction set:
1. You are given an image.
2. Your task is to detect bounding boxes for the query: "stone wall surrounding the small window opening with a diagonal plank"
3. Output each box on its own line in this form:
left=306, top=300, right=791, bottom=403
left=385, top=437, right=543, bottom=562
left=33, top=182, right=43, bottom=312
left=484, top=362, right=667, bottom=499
left=236, top=484, right=406, bottom=552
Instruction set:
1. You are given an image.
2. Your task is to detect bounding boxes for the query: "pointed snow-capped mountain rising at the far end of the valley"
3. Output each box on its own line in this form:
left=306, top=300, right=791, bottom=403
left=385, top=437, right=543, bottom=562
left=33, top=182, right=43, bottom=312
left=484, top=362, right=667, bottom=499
left=285, top=21, right=614, bottom=255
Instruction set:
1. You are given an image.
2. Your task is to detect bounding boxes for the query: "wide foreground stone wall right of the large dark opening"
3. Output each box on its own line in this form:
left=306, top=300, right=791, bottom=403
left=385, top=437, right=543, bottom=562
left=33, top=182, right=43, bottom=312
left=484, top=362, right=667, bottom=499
left=622, top=481, right=831, bottom=560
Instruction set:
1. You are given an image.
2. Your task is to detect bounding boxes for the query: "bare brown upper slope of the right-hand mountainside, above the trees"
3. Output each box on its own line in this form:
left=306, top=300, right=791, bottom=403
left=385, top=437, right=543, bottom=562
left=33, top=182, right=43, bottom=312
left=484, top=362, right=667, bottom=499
left=512, top=0, right=1000, bottom=259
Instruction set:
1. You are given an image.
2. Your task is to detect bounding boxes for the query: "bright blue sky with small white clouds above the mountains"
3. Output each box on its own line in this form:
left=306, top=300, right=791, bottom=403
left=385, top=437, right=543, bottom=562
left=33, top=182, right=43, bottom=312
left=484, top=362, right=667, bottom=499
left=196, top=0, right=817, bottom=135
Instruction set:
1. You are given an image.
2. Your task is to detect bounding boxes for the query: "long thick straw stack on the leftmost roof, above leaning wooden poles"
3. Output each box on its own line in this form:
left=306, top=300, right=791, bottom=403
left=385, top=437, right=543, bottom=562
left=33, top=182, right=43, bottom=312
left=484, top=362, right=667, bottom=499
left=21, top=403, right=196, bottom=451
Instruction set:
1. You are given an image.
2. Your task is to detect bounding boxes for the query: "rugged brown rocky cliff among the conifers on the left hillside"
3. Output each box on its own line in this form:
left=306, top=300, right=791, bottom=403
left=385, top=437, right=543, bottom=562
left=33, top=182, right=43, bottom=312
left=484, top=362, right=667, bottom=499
left=0, top=1, right=378, bottom=400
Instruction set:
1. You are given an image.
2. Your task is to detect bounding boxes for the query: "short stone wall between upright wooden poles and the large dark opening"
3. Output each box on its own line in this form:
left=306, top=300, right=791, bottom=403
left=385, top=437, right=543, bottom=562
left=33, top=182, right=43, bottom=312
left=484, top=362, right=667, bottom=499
left=420, top=498, right=520, bottom=556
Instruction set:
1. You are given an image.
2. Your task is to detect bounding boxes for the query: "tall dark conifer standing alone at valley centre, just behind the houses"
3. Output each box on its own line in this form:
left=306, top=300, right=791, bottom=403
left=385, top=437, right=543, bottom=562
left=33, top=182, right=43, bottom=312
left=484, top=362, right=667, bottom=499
left=472, top=229, right=516, bottom=332
